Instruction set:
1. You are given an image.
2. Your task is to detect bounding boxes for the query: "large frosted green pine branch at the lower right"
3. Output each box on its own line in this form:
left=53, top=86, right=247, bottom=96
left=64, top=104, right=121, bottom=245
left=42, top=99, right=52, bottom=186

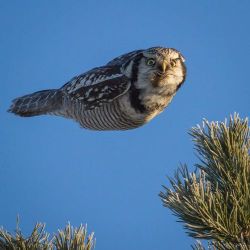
left=160, top=114, right=250, bottom=250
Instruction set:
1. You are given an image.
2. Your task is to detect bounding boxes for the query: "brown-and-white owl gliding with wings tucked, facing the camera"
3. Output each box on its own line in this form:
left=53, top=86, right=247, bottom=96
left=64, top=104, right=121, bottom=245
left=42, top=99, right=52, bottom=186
left=8, top=47, right=186, bottom=130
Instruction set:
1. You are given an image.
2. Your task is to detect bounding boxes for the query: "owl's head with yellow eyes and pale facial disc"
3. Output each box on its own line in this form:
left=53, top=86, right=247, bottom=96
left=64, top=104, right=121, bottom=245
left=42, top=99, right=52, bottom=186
left=138, top=47, right=186, bottom=87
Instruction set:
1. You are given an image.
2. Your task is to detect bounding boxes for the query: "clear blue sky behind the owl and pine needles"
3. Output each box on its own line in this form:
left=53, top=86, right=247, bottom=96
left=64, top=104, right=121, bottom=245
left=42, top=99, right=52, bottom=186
left=0, top=0, right=250, bottom=250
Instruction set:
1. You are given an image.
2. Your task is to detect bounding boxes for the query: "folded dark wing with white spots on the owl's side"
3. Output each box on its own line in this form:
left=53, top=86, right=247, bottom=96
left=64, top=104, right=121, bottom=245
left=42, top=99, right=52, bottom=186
left=62, top=66, right=130, bottom=110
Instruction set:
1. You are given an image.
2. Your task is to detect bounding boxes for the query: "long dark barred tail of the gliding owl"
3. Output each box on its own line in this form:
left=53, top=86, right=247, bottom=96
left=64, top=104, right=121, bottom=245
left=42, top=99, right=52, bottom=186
left=8, top=89, right=63, bottom=117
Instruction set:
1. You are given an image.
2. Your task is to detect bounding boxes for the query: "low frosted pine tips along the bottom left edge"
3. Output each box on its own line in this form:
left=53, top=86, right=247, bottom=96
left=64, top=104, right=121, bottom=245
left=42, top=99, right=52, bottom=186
left=0, top=223, right=95, bottom=250
